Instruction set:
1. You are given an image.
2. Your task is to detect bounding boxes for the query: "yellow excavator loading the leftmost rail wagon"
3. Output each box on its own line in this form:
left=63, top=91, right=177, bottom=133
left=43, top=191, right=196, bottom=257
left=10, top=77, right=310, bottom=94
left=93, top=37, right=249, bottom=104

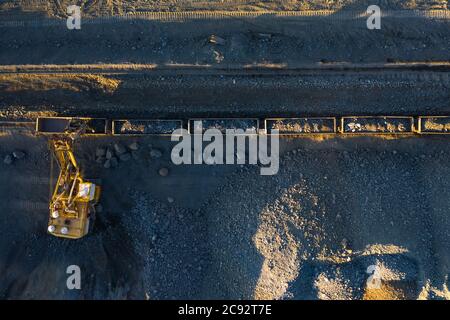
left=47, top=123, right=100, bottom=239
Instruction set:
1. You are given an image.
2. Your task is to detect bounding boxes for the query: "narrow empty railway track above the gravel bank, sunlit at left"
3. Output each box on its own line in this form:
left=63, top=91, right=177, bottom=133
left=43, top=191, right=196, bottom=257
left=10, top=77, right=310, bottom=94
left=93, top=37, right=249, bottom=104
left=0, top=61, right=450, bottom=76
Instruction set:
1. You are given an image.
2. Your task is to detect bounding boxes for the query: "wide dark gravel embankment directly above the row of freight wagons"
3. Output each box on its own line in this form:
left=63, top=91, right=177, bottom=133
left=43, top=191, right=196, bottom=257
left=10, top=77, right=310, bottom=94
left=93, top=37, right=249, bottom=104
left=0, top=71, right=450, bottom=119
